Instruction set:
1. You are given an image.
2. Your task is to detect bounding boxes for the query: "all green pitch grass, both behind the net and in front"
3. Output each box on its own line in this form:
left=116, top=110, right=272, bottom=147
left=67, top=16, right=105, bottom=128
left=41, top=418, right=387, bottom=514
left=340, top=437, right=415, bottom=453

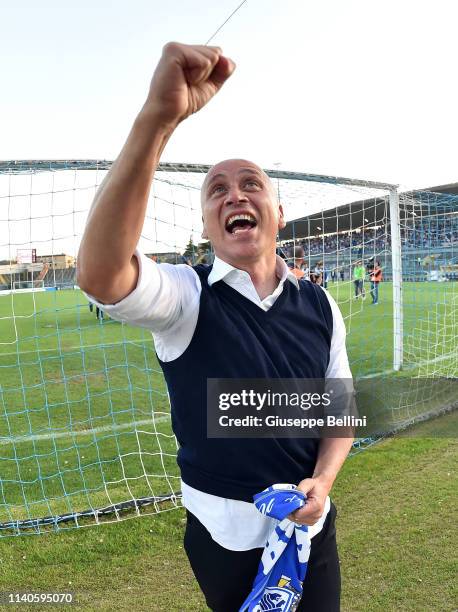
left=0, top=283, right=458, bottom=612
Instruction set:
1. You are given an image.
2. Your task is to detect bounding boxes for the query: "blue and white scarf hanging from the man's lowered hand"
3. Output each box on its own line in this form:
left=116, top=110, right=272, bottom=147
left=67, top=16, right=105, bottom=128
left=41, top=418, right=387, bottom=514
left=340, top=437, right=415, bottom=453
left=239, top=484, right=310, bottom=612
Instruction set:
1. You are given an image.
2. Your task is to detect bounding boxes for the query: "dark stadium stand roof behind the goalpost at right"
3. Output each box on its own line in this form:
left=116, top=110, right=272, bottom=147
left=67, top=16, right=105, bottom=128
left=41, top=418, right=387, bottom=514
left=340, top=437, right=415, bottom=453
left=279, top=183, right=458, bottom=240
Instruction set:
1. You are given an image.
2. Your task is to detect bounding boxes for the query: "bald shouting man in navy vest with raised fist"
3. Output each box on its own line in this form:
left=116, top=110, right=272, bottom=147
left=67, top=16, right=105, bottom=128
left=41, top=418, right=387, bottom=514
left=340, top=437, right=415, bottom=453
left=78, top=43, right=351, bottom=612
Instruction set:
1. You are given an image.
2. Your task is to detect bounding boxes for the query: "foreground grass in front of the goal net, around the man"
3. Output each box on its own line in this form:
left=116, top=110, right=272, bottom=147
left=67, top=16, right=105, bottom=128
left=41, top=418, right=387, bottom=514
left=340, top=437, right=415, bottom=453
left=0, top=413, right=458, bottom=612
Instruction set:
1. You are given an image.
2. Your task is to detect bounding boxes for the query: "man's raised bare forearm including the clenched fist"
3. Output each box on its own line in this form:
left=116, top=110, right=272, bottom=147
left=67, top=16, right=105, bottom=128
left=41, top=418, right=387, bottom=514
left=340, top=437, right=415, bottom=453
left=77, top=43, right=235, bottom=303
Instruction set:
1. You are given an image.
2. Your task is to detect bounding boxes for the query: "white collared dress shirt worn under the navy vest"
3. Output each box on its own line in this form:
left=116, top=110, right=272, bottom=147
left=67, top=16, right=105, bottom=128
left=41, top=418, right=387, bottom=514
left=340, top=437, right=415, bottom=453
left=86, top=251, right=351, bottom=550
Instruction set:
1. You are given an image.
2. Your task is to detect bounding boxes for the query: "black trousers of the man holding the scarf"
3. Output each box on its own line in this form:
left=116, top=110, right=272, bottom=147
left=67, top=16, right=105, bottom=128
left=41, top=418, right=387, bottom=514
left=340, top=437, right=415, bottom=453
left=184, top=504, right=340, bottom=612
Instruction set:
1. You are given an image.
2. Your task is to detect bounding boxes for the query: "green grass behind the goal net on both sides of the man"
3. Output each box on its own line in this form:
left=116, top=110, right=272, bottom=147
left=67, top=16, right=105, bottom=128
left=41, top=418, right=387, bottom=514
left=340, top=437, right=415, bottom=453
left=0, top=283, right=458, bottom=536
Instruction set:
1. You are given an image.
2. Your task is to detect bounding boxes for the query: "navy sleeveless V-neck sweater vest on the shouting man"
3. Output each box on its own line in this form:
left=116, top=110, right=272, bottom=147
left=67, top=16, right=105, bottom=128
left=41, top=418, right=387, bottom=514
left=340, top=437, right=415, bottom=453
left=159, top=266, right=332, bottom=502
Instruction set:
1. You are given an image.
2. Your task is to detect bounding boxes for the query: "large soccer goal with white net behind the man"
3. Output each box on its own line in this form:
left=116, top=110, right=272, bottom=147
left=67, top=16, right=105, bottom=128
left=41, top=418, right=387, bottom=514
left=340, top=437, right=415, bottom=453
left=0, top=160, right=458, bottom=536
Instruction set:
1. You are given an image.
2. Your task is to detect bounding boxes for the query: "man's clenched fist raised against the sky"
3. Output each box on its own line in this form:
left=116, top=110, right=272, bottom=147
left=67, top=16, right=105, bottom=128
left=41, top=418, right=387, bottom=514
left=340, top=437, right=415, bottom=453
left=146, top=42, right=235, bottom=125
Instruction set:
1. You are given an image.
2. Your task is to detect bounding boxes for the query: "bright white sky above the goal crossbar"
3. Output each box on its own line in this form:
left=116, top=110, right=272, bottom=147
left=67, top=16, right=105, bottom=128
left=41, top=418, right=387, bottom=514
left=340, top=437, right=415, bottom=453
left=0, top=0, right=458, bottom=252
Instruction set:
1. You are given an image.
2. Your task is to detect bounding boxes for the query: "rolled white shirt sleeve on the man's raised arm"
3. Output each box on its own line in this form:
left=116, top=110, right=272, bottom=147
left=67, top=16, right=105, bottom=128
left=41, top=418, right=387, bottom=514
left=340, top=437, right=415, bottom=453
left=83, top=250, right=202, bottom=361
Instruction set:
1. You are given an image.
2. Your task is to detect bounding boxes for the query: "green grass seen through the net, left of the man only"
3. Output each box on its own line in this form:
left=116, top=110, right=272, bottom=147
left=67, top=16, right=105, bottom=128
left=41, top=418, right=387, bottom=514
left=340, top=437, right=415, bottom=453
left=0, top=291, right=179, bottom=521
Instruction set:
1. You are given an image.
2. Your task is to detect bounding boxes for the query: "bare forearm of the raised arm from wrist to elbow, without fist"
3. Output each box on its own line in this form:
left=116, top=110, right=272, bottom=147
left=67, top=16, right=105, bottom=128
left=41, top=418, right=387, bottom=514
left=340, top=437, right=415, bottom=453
left=78, top=106, right=173, bottom=301
